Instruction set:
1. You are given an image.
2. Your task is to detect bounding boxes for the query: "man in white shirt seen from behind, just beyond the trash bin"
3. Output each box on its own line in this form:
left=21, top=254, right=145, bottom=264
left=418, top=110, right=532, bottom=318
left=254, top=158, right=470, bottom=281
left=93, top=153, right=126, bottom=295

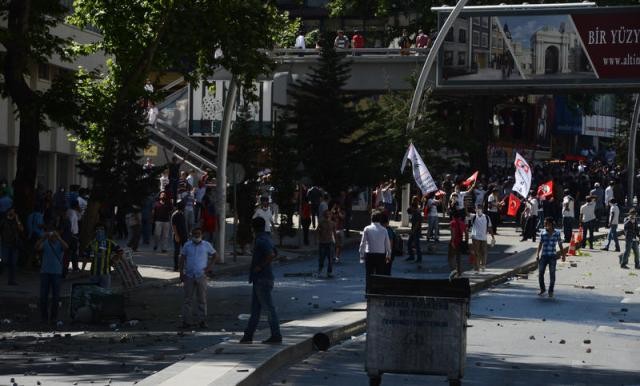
left=359, top=210, right=391, bottom=293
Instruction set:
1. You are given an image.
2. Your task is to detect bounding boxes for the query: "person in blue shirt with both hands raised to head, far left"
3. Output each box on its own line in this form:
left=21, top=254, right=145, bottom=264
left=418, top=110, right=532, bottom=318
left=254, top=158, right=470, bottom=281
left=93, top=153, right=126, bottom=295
left=35, top=230, right=69, bottom=323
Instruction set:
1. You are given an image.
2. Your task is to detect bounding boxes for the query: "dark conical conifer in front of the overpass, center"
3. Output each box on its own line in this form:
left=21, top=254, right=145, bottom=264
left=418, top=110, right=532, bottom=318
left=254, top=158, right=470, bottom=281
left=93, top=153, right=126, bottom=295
left=287, top=40, right=363, bottom=193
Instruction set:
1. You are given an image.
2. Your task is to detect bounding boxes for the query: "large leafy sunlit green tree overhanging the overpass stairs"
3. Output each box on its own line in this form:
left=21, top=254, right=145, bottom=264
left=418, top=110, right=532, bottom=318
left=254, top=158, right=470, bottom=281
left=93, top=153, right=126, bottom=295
left=60, top=0, right=288, bottom=238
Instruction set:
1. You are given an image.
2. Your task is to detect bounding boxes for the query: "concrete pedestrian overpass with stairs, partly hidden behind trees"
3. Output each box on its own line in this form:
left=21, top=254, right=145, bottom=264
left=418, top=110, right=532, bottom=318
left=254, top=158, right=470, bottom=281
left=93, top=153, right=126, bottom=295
left=149, top=48, right=429, bottom=171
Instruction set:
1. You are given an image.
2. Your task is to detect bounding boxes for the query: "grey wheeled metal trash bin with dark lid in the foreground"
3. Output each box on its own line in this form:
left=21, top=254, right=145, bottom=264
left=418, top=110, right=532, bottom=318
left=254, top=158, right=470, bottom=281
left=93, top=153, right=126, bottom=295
left=365, top=276, right=471, bottom=385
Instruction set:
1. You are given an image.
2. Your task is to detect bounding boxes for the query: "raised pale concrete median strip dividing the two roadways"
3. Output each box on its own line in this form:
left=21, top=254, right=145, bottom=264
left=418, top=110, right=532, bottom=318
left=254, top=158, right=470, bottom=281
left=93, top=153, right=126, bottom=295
left=138, top=225, right=616, bottom=386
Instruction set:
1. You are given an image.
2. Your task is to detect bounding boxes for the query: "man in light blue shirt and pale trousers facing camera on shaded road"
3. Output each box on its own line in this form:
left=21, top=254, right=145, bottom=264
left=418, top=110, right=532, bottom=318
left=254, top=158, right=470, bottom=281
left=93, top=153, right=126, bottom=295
left=178, top=228, right=218, bottom=328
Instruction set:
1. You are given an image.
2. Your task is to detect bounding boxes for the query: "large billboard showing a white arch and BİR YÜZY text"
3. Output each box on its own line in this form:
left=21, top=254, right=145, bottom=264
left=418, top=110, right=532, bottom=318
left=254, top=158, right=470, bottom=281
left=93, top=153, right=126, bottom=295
left=436, top=7, right=640, bottom=92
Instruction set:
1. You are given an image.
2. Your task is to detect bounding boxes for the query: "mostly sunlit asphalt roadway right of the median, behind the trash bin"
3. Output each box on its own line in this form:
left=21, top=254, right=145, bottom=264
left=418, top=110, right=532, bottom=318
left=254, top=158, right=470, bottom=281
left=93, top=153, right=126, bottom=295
left=265, top=246, right=640, bottom=386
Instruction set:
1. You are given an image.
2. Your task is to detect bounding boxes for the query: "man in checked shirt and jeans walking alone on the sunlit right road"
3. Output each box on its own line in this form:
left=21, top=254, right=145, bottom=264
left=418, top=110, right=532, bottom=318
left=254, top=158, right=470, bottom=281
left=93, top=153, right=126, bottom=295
left=536, top=217, right=566, bottom=298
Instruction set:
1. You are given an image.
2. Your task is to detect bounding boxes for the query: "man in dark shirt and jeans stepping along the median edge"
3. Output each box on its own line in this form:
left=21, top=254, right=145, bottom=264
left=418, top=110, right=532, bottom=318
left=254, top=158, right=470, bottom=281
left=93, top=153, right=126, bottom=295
left=239, top=217, right=282, bottom=344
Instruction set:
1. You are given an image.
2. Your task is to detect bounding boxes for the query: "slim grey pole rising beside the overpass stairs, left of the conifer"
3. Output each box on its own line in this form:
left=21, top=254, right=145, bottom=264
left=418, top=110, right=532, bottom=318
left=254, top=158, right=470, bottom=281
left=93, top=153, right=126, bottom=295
left=215, top=77, right=238, bottom=263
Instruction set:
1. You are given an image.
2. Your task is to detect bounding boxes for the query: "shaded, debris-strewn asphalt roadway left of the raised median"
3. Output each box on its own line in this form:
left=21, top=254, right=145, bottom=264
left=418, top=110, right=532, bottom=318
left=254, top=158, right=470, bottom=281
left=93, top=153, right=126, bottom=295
left=0, top=231, right=528, bottom=386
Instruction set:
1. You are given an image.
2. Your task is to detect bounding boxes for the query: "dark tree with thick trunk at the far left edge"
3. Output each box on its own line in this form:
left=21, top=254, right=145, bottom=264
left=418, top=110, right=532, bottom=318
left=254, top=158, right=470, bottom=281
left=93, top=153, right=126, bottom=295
left=0, top=0, right=71, bottom=216
